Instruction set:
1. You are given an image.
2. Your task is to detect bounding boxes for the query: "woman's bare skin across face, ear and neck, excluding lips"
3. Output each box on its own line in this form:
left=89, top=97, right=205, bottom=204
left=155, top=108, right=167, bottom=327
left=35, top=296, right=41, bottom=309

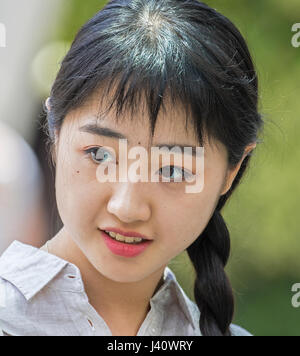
left=39, top=90, right=255, bottom=336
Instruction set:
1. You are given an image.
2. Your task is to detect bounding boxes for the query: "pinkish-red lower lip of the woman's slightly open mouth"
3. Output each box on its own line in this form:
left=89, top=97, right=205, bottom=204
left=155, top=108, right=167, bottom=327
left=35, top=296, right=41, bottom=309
left=101, top=230, right=152, bottom=257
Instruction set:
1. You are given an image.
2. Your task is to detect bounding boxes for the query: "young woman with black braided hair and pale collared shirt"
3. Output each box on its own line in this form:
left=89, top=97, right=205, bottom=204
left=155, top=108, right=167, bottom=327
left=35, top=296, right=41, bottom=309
left=0, top=0, right=263, bottom=336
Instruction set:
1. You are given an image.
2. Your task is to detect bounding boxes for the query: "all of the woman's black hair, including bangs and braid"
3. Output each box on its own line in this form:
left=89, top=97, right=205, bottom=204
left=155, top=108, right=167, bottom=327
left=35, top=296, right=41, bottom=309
left=47, top=0, right=263, bottom=336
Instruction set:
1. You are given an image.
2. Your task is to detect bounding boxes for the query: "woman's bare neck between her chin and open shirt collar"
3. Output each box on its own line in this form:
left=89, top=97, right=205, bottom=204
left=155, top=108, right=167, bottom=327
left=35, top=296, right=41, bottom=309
left=49, top=229, right=165, bottom=335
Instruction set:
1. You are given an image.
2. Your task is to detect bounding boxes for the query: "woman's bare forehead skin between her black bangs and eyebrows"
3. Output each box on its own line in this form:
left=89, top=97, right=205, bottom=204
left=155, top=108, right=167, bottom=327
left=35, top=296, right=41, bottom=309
left=62, top=89, right=225, bottom=160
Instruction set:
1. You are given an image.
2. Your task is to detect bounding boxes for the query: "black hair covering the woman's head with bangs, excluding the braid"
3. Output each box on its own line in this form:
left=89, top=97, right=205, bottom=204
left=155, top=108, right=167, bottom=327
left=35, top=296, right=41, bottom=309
left=49, top=0, right=260, bottom=163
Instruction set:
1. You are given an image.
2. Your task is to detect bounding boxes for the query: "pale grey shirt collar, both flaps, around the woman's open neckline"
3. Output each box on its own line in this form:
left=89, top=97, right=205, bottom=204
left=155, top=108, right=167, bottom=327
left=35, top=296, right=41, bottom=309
left=0, top=240, right=199, bottom=329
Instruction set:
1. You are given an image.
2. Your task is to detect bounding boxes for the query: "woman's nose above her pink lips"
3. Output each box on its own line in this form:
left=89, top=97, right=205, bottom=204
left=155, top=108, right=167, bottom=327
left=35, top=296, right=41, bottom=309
left=107, top=182, right=151, bottom=223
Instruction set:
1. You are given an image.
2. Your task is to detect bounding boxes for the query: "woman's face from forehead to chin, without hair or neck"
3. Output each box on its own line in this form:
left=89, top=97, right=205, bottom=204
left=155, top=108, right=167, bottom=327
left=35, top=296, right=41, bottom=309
left=56, top=92, right=234, bottom=282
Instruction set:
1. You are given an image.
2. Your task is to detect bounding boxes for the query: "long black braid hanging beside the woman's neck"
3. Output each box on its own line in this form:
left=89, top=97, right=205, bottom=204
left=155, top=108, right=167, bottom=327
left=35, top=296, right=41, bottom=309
left=187, top=209, right=234, bottom=336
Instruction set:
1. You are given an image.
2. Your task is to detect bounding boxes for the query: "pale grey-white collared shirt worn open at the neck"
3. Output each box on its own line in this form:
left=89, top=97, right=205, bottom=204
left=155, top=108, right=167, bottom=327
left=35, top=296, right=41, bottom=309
left=0, top=241, right=251, bottom=336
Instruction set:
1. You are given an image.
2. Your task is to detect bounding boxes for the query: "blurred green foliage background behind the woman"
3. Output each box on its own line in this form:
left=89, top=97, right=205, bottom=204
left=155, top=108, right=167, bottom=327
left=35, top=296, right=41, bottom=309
left=33, top=0, right=300, bottom=336
